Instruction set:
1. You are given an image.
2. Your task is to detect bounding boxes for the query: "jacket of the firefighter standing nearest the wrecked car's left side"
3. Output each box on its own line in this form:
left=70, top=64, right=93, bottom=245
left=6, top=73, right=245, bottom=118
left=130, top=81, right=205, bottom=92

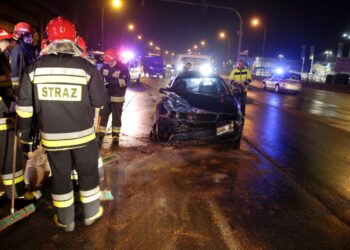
left=101, top=62, right=130, bottom=102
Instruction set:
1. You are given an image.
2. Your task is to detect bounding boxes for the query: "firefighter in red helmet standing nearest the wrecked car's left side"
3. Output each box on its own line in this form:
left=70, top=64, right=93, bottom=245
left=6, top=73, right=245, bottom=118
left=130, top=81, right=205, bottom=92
left=98, top=49, right=130, bottom=147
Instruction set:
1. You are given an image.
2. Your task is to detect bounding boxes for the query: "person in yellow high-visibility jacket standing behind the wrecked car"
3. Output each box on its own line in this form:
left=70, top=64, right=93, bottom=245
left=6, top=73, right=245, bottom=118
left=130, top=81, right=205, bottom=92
left=229, top=60, right=252, bottom=117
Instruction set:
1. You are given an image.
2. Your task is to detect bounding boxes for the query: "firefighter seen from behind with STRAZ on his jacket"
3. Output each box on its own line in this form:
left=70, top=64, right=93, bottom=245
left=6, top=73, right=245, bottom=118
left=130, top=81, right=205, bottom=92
left=16, top=17, right=106, bottom=231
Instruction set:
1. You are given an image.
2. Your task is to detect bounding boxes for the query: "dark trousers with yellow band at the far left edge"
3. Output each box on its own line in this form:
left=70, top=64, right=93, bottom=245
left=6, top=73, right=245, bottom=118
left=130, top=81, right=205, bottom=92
left=0, top=130, right=26, bottom=199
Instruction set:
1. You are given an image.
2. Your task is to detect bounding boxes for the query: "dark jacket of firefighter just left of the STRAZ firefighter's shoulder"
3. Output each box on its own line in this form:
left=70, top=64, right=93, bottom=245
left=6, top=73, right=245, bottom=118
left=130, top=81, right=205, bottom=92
left=10, top=40, right=35, bottom=87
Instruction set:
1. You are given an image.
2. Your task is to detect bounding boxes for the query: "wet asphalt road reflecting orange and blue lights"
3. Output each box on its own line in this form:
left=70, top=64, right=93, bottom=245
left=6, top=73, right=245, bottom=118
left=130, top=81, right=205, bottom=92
left=0, top=79, right=350, bottom=249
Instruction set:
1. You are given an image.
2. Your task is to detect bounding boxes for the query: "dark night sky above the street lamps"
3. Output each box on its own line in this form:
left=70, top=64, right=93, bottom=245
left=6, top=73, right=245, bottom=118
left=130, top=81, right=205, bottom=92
left=50, top=0, right=350, bottom=59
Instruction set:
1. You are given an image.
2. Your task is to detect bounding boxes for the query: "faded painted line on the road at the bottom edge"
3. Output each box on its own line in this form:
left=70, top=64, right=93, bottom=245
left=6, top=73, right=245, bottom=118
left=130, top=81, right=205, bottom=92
left=207, top=198, right=244, bottom=250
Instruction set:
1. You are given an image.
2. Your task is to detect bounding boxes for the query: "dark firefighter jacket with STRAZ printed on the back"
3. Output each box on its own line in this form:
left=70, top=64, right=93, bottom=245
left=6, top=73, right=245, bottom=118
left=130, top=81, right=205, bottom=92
left=16, top=53, right=106, bottom=151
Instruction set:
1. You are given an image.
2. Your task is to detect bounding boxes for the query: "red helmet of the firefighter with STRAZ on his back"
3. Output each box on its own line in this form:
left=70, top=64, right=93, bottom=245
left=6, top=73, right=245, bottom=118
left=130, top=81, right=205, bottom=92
left=46, top=16, right=76, bottom=42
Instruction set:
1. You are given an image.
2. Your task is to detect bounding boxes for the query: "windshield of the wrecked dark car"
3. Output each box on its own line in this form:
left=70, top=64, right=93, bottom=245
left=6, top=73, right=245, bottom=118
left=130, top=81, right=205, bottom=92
left=173, top=77, right=229, bottom=96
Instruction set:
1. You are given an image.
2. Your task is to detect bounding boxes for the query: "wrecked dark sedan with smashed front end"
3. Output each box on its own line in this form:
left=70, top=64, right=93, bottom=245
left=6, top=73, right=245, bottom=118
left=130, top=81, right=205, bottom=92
left=152, top=71, right=244, bottom=149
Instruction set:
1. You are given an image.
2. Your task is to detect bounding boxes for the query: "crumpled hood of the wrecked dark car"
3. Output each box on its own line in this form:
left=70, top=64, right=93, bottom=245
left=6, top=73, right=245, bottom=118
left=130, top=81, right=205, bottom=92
left=164, top=92, right=237, bottom=113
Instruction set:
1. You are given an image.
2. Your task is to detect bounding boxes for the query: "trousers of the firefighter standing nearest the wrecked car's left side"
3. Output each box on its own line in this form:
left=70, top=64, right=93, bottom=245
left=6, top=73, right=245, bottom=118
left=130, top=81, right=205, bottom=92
left=99, top=102, right=124, bottom=140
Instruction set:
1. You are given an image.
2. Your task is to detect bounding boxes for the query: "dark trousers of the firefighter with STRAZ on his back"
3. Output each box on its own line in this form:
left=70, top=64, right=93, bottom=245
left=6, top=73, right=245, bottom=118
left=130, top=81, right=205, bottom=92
left=47, top=140, right=101, bottom=225
